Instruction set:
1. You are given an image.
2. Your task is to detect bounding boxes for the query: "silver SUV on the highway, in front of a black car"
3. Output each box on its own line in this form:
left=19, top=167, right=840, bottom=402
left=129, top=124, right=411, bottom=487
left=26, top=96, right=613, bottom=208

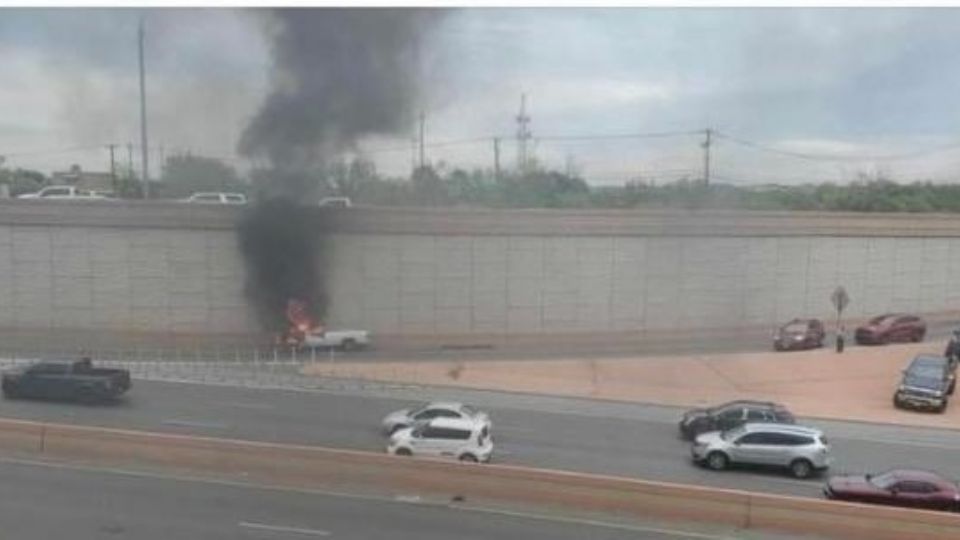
left=690, top=423, right=832, bottom=478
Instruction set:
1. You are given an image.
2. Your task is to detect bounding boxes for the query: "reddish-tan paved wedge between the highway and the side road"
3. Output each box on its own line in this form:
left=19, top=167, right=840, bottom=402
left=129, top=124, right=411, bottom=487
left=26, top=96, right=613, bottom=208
left=304, top=341, right=960, bottom=428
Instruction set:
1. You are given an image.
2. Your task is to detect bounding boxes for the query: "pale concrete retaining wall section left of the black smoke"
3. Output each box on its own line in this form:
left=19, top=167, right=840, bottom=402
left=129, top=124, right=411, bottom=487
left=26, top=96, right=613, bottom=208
left=0, top=201, right=256, bottom=340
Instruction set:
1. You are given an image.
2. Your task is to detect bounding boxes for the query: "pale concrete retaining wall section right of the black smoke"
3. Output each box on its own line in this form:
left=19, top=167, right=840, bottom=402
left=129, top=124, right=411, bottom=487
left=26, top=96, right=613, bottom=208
left=331, top=211, right=960, bottom=335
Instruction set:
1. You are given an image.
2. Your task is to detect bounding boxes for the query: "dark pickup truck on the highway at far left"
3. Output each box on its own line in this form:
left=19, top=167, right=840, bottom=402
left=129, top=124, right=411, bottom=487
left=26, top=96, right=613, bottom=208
left=2, top=358, right=131, bottom=402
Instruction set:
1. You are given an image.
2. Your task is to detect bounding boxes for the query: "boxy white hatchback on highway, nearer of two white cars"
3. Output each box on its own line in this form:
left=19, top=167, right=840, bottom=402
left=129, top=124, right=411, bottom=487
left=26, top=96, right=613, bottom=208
left=387, top=418, right=493, bottom=463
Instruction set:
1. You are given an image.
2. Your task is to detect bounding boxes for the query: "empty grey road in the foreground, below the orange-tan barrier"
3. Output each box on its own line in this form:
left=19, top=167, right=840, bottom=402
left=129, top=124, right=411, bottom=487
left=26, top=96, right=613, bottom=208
left=0, top=461, right=736, bottom=540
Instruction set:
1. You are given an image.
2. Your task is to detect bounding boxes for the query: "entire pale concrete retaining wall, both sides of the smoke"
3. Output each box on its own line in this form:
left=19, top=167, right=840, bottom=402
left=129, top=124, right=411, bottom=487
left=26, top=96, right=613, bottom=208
left=0, top=201, right=960, bottom=344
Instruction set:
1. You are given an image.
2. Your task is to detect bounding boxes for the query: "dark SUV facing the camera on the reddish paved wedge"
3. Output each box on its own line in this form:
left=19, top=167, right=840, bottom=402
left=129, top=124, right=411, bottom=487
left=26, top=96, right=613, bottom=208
left=893, top=355, right=957, bottom=413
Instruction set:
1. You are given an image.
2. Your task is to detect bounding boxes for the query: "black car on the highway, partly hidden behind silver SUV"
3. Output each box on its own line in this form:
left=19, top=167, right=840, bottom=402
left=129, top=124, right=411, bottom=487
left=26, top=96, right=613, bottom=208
left=680, top=400, right=796, bottom=440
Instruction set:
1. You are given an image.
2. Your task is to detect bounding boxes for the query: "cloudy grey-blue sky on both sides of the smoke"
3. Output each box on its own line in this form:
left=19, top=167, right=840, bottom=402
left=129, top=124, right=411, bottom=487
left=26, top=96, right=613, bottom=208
left=0, top=8, right=960, bottom=184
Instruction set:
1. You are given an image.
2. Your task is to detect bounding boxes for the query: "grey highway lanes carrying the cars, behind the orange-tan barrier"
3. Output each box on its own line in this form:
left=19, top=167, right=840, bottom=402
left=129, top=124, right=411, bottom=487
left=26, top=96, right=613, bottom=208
left=0, top=381, right=960, bottom=497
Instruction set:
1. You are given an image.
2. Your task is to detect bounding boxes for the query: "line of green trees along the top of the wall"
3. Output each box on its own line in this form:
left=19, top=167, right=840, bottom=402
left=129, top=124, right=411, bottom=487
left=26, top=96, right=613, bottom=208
left=0, top=154, right=960, bottom=212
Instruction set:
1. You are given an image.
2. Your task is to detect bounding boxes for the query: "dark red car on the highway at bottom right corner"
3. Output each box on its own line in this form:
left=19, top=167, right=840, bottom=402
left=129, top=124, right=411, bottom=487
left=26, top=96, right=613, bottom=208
left=823, top=469, right=960, bottom=512
